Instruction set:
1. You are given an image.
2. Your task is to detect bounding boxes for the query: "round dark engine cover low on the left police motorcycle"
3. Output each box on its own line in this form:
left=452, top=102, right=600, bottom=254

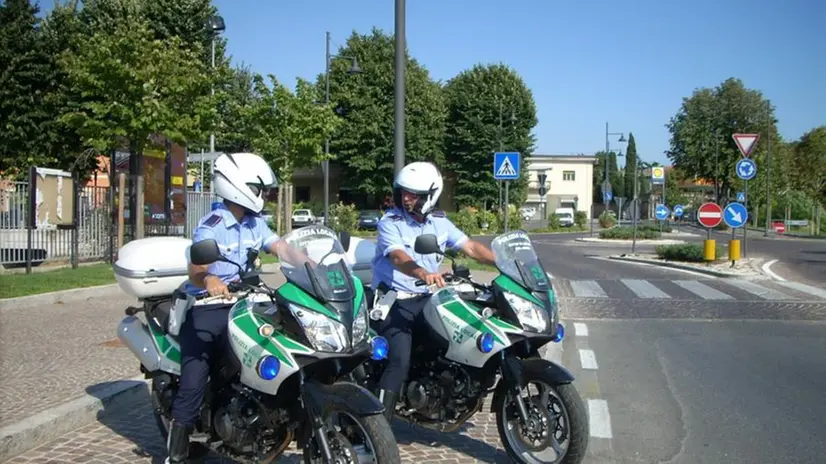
left=212, top=396, right=260, bottom=451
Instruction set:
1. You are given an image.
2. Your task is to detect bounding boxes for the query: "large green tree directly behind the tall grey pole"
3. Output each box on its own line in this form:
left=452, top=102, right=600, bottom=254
left=317, top=28, right=445, bottom=203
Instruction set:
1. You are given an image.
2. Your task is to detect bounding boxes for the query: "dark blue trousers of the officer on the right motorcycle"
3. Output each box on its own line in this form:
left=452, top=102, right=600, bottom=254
left=379, top=294, right=430, bottom=394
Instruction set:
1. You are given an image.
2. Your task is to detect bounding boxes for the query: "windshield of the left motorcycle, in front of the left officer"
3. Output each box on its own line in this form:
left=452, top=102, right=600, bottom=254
left=278, top=226, right=355, bottom=302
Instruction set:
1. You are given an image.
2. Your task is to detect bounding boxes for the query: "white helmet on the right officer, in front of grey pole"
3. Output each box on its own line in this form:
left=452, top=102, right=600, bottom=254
left=393, top=161, right=444, bottom=218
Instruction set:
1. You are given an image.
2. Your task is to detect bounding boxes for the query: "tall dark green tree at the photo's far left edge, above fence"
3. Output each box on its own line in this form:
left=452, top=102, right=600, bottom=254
left=0, top=0, right=55, bottom=176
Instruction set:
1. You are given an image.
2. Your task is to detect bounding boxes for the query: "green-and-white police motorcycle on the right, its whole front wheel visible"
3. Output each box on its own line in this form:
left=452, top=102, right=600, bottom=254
left=353, top=231, right=588, bottom=464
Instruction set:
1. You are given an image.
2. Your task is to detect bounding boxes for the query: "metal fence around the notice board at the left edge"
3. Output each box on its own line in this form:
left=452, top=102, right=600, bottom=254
left=0, top=182, right=113, bottom=268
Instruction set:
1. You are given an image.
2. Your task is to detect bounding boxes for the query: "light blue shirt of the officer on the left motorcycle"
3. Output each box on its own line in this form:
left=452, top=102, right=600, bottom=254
left=184, top=203, right=278, bottom=295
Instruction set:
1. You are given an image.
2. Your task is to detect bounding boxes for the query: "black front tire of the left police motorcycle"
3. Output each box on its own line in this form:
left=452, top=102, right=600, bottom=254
left=304, top=405, right=402, bottom=464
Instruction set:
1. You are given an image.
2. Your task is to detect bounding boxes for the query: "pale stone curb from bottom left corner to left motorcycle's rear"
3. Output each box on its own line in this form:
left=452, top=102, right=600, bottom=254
left=0, top=376, right=149, bottom=462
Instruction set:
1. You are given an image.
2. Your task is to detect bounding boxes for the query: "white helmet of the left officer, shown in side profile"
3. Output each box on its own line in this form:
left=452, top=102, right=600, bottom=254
left=213, top=153, right=278, bottom=214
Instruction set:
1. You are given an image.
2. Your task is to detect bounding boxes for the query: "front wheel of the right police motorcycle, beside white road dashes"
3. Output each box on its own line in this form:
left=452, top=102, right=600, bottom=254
left=492, top=363, right=588, bottom=464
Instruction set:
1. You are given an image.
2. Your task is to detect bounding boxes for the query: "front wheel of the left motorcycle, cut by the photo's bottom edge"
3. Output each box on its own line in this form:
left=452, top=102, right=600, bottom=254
left=304, top=405, right=402, bottom=464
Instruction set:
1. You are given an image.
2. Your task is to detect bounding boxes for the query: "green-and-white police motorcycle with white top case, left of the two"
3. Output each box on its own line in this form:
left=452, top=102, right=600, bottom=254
left=115, top=226, right=401, bottom=463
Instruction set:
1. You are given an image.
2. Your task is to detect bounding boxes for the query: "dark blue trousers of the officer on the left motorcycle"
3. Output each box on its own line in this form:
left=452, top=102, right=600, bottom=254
left=172, top=304, right=231, bottom=426
